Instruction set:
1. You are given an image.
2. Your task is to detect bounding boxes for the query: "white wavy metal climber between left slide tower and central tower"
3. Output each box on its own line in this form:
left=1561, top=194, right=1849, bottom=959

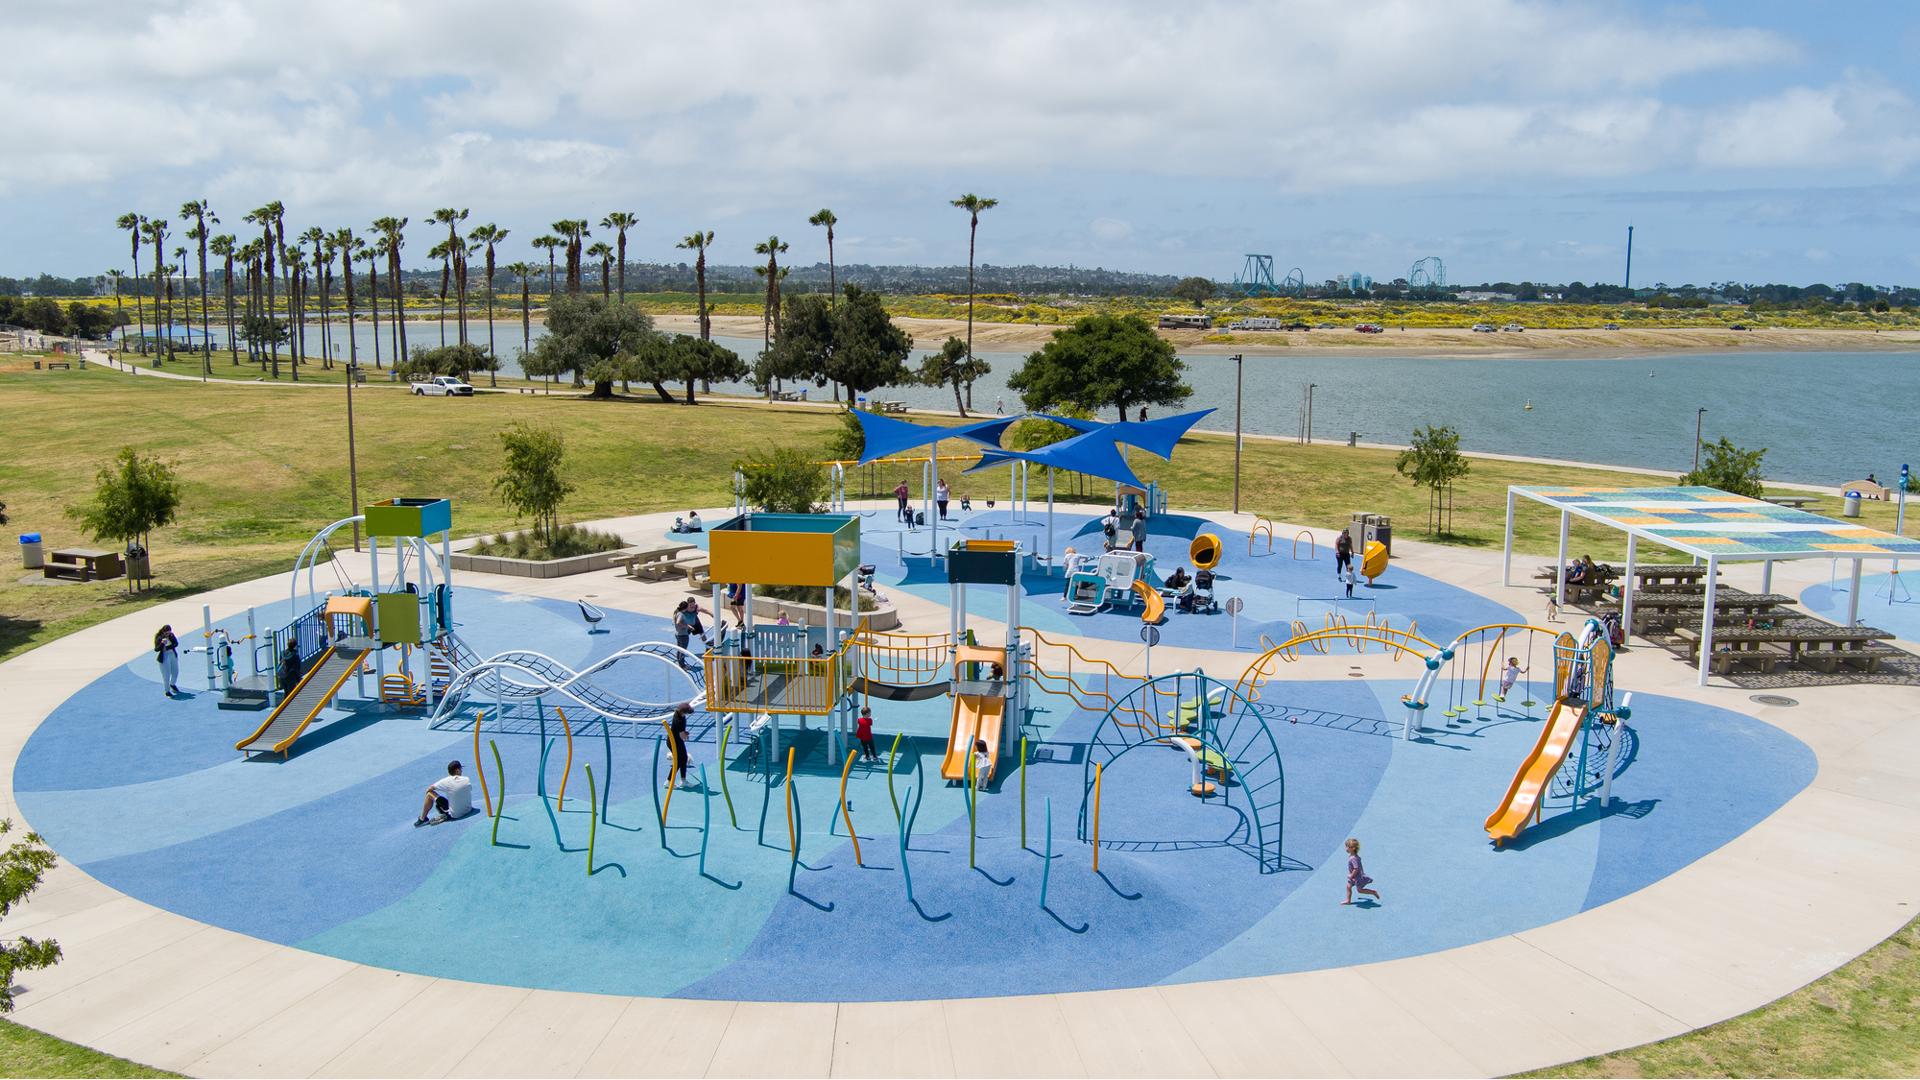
left=432, top=642, right=707, bottom=723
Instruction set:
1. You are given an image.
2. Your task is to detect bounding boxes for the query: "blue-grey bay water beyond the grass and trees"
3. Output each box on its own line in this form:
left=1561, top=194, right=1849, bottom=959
left=127, top=319, right=1920, bottom=484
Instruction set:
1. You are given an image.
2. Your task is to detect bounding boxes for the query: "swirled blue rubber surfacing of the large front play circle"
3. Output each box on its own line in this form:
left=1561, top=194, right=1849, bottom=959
left=13, top=557, right=1814, bottom=1001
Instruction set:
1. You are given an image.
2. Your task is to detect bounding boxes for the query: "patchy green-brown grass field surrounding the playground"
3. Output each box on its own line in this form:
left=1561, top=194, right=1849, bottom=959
left=0, top=357, right=1920, bottom=1076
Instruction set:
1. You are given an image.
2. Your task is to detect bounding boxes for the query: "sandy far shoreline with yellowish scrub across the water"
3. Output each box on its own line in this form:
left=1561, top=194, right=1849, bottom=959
left=653, top=315, right=1920, bottom=359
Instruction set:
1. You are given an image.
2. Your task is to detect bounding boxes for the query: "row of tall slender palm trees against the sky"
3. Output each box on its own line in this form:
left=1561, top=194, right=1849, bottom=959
left=109, top=192, right=998, bottom=390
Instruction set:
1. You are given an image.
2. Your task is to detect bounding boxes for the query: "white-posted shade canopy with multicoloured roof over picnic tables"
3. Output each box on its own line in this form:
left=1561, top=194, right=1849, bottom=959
left=1501, top=484, right=1920, bottom=686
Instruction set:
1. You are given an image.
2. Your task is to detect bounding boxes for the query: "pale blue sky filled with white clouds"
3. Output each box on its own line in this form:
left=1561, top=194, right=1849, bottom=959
left=11, top=0, right=1920, bottom=284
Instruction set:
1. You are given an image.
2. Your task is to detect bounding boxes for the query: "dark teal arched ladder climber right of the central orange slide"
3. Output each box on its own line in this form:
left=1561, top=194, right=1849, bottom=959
left=1077, top=671, right=1286, bottom=874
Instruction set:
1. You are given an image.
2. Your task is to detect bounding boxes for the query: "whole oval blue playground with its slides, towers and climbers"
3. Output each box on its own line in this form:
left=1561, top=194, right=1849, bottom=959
left=0, top=409, right=1904, bottom=1072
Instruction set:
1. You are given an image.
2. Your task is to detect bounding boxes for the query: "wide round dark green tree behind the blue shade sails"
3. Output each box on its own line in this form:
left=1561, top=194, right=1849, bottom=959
left=1006, top=315, right=1192, bottom=421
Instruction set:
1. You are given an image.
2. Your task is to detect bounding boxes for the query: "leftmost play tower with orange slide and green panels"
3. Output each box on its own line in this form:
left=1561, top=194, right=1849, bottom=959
left=234, top=498, right=453, bottom=759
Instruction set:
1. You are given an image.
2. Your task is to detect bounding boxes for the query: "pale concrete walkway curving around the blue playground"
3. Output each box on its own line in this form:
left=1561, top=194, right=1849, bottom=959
left=0, top=513, right=1920, bottom=1076
